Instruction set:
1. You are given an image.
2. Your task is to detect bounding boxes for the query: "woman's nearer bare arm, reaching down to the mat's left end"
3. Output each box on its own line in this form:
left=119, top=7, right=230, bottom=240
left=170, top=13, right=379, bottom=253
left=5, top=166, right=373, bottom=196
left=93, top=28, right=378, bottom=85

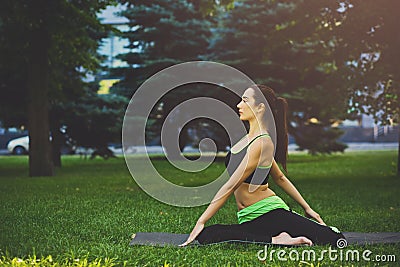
left=181, top=138, right=263, bottom=246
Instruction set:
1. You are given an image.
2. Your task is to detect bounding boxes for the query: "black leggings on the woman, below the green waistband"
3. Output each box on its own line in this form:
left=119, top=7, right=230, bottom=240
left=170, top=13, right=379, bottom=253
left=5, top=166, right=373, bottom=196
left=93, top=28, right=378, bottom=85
left=197, top=209, right=344, bottom=246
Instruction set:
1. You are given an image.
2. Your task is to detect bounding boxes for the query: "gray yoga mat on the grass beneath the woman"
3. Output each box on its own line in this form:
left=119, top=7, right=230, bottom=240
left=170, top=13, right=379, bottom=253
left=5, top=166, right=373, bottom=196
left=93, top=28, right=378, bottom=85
left=130, top=232, right=400, bottom=246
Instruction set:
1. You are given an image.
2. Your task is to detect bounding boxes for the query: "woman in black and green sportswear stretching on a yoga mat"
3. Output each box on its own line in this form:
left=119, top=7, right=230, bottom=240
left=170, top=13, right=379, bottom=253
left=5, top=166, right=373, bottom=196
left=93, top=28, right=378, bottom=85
left=181, top=85, right=344, bottom=246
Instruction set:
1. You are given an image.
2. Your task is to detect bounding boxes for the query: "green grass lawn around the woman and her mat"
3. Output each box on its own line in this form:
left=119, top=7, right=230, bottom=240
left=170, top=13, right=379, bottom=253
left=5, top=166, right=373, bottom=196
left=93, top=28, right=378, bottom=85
left=0, top=151, right=400, bottom=266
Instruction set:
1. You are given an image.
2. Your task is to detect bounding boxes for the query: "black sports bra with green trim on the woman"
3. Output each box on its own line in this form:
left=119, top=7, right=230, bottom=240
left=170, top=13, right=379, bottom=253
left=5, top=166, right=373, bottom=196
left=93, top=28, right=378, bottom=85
left=225, top=134, right=272, bottom=185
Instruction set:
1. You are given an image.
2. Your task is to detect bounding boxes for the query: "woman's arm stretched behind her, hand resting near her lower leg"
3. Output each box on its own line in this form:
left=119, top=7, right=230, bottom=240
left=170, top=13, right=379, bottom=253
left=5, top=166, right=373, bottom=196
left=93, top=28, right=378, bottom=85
left=270, top=160, right=325, bottom=225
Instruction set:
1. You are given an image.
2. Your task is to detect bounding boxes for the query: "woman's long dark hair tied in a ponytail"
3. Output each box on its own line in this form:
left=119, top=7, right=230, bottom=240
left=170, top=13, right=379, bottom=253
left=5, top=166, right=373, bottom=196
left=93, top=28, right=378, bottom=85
left=250, top=84, right=289, bottom=171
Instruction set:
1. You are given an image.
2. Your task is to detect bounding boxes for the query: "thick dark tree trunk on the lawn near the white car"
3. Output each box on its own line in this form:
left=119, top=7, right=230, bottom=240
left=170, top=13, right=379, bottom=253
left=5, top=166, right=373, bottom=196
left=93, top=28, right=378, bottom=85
left=27, top=2, right=53, bottom=177
